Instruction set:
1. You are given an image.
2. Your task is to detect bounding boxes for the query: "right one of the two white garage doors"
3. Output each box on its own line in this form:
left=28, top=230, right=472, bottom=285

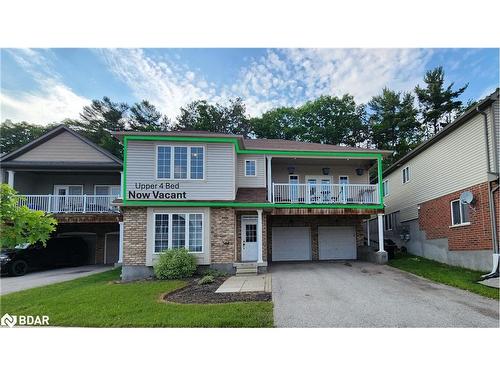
left=318, top=227, right=356, bottom=260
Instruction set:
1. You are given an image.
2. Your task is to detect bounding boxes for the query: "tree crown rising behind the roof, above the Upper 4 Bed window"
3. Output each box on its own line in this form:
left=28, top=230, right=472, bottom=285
left=129, top=100, right=170, bottom=131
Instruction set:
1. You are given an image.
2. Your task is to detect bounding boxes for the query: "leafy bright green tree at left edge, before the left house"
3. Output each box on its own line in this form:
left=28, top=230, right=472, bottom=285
left=0, top=184, right=57, bottom=249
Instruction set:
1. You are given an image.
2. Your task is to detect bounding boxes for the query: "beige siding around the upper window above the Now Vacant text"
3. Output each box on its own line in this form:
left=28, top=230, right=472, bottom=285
left=126, top=141, right=235, bottom=200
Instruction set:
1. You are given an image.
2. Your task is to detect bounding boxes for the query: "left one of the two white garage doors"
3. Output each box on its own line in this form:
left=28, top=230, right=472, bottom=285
left=272, top=227, right=311, bottom=261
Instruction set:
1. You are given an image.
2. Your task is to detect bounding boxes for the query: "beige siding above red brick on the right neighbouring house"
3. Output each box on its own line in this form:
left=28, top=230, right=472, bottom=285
left=384, top=114, right=486, bottom=221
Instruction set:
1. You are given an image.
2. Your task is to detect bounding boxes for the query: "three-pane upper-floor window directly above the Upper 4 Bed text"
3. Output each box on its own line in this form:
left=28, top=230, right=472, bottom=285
left=156, top=146, right=205, bottom=180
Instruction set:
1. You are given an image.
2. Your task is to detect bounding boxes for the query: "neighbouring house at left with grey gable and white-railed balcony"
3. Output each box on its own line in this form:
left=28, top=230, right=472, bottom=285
left=0, top=126, right=122, bottom=264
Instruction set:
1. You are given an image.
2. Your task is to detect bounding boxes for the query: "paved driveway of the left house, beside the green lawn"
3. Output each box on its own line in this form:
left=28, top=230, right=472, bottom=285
left=0, top=265, right=113, bottom=295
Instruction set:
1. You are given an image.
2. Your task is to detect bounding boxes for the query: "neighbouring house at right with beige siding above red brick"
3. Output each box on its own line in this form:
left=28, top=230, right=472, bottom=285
left=365, top=89, right=500, bottom=271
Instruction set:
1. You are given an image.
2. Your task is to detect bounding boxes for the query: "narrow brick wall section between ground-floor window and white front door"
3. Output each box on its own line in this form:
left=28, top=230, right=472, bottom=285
left=210, top=208, right=236, bottom=264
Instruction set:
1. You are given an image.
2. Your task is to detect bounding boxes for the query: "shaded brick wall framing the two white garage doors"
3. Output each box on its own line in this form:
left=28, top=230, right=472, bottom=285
left=267, top=215, right=368, bottom=260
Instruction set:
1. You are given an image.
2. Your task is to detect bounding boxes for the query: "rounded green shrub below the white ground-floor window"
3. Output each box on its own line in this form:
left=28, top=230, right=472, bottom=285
left=153, top=249, right=196, bottom=280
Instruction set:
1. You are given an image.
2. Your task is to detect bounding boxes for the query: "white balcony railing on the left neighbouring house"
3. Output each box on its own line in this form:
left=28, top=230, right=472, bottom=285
left=19, top=195, right=118, bottom=213
